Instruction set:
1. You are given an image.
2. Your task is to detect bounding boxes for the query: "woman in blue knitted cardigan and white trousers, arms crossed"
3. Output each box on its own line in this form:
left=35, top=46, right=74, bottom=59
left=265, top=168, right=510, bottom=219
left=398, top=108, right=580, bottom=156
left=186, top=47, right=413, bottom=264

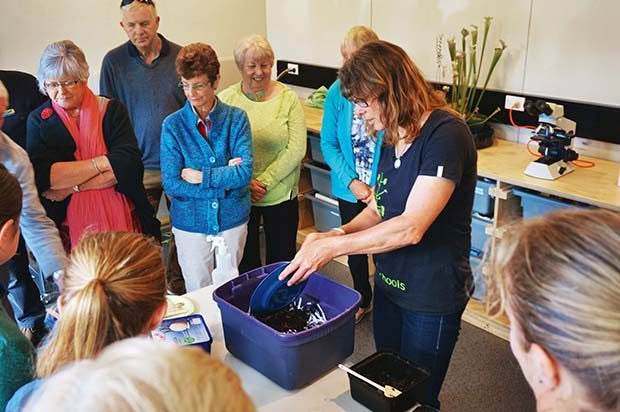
left=161, top=43, right=252, bottom=292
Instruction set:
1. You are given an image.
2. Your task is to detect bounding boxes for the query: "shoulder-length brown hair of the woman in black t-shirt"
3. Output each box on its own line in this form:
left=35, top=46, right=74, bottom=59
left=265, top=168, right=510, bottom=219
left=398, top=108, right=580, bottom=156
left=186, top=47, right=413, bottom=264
left=338, top=40, right=460, bottom=146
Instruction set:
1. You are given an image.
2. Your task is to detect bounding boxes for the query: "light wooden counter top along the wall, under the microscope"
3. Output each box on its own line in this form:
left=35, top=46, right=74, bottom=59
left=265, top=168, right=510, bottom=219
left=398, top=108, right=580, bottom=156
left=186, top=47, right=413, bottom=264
left=304, top=105, right=620, bottom=211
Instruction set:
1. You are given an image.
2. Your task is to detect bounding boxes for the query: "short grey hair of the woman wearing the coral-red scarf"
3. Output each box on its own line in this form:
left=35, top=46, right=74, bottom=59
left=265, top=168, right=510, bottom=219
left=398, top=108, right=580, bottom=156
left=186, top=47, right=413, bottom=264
left=37, top=40, right=90, bottom=94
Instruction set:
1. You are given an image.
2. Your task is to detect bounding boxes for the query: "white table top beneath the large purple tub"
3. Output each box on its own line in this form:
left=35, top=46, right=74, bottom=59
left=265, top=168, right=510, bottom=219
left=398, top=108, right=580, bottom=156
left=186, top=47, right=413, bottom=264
left=185, top=286, right=368, bottom=412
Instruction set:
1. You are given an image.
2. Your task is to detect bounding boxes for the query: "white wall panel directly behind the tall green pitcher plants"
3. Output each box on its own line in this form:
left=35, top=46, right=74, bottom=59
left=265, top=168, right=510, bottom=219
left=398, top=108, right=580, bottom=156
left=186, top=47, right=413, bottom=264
left=372, top=0, right=529, bottom=91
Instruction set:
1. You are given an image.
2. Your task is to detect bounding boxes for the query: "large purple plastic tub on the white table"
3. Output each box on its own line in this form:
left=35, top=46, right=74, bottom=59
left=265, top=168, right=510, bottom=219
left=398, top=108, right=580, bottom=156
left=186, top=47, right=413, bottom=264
left=213, top=263, right=361, bottom=390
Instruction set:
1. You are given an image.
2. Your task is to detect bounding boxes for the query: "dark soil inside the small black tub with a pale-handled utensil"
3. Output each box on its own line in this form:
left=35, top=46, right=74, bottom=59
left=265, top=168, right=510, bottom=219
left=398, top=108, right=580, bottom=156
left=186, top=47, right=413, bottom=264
left=355, top=354, right=427, bottom=392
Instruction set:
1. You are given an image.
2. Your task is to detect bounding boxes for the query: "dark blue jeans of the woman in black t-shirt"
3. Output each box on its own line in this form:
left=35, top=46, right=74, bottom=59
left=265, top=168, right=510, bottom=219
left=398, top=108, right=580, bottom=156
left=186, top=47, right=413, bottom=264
left=372, top=288, right=463, bottom=409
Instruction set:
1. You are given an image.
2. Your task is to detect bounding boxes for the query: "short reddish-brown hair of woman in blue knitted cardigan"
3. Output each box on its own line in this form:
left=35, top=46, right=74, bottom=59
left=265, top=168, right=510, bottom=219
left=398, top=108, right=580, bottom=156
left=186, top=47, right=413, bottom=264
left=175, top=43, right=220, bottom=84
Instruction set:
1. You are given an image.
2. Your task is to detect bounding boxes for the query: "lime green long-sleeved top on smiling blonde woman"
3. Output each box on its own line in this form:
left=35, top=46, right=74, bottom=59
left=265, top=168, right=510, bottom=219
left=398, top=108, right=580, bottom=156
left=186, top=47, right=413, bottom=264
left=218, top=83, right=307, bottom=206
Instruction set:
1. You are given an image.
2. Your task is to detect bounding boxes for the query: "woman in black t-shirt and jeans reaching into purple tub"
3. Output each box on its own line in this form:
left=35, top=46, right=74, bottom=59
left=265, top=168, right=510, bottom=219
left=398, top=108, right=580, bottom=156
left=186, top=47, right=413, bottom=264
left=281, top=41, right=477, bottom=409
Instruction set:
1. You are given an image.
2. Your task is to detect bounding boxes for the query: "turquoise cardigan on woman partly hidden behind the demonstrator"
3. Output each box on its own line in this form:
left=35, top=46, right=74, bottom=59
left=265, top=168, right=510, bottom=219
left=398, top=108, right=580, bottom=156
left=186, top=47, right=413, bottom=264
left=321, top=80, right=383, bottom=203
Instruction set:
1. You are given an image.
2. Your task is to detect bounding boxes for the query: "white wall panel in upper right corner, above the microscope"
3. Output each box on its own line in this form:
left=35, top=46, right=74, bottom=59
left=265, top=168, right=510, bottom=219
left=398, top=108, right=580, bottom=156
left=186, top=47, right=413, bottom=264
left=524, top=0, right=620, bottom=106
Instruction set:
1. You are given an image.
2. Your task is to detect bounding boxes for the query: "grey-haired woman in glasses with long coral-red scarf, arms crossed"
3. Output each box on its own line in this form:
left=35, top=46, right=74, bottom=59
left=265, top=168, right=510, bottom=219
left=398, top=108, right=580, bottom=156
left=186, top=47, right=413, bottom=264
left=27, top=40, right=160, bottom=251
